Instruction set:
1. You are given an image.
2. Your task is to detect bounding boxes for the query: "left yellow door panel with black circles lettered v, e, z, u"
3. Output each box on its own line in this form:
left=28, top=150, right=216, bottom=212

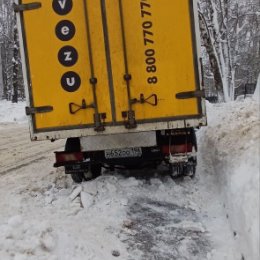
left=23, top=0, right=111, bottom=129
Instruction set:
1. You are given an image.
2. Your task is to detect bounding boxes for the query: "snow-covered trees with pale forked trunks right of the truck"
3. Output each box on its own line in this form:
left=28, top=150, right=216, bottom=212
left=199, top=0, right=260, bottom=101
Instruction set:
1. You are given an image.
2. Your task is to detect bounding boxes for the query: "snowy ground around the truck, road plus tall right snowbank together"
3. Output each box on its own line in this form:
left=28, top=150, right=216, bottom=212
left=0, top=101, right=259, bottom=260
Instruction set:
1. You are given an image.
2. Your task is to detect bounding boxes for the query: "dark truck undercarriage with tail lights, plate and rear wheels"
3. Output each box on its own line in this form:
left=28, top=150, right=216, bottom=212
left=54, top=128, right=197, bottom=183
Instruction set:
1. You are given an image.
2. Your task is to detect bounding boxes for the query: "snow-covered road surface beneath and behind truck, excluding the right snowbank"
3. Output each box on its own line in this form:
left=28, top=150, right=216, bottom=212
left=0, top=124, right=239, bottom=260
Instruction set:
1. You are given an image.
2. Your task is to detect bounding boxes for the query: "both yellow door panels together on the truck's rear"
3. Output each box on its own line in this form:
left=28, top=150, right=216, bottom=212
left=22, top=0, right=199, bottom=130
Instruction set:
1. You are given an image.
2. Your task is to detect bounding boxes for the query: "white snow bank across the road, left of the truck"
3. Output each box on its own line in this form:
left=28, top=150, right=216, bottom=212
left=0, top=100, right=27, bottom=123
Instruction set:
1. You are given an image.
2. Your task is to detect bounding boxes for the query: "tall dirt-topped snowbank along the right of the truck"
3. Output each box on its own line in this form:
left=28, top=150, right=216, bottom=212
left=199, top=99, right=260, bottom=260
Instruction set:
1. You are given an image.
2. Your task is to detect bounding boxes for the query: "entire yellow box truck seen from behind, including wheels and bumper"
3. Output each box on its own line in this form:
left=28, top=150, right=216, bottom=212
left=14, top=0, right=206, bottom=181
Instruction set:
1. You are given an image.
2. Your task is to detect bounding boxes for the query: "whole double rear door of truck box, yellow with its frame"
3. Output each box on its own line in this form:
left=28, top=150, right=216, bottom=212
left=15, top=0, right=203, bottom=139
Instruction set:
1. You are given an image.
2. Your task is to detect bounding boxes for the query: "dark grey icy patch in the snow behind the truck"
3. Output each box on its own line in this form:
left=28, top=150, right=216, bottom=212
left=124, top=198, right=211, bottom=260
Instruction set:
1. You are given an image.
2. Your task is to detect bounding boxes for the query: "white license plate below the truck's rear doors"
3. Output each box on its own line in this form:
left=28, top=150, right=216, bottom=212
left=105, top=147, right=142, bottom=159
